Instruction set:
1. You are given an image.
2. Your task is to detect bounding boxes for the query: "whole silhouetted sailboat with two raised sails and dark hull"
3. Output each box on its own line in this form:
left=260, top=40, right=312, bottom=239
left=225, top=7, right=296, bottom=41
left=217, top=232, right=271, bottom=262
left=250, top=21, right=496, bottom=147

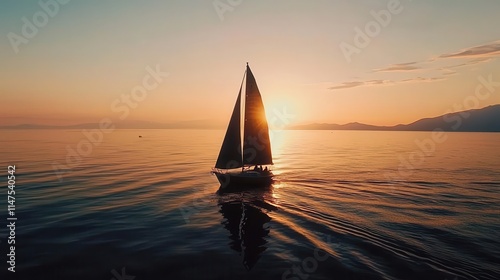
left=212, top=63, right=273, bottom=189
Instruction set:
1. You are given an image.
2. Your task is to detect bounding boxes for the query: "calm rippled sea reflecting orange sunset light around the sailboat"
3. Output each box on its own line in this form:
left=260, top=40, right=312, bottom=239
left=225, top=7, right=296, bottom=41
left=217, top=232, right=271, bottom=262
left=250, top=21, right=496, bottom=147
left=0, top=130, right=500, bottom=280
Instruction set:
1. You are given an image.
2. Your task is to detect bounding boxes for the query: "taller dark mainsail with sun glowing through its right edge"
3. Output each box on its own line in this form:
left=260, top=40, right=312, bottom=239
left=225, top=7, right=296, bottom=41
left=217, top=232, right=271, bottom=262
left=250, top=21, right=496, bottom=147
left=243, top=65, right=273, bottom=165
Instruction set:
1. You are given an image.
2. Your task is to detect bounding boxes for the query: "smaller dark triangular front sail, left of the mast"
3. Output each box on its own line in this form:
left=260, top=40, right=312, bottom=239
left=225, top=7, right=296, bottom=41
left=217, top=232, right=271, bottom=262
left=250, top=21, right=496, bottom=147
left=215, top=86, right=243, bottom=169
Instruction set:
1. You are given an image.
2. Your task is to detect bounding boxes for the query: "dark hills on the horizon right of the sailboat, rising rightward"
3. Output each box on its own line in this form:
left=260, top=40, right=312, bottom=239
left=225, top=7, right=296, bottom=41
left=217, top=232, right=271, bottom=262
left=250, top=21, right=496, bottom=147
left=289, top=104, right=500, bottom=132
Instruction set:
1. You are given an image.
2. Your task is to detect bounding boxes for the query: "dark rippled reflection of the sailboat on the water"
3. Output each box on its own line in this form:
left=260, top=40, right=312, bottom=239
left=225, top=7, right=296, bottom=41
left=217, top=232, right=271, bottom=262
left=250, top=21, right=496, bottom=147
left=219, top=191, right=278, bottom=270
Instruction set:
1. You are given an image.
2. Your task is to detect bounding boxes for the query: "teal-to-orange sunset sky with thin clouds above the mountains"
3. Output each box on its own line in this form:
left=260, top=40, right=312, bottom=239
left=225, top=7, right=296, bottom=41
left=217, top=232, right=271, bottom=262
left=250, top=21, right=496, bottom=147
left=0, top=0, right=500, bottom=125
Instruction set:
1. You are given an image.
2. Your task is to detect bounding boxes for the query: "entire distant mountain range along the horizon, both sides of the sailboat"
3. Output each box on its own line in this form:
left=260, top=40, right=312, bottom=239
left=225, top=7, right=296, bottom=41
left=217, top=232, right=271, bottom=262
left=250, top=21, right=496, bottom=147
left=0, top=104, right=500, bottom=132
